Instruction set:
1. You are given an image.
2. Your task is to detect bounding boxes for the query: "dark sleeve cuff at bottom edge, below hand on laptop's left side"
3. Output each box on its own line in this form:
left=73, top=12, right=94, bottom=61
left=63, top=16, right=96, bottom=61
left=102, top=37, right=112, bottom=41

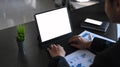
left=48, top=56, right=70, bottom=67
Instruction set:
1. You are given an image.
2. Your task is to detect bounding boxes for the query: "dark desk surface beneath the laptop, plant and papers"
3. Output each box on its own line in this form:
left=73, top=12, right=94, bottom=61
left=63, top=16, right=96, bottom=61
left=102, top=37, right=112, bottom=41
left=0, top=2, right=117, bottom=67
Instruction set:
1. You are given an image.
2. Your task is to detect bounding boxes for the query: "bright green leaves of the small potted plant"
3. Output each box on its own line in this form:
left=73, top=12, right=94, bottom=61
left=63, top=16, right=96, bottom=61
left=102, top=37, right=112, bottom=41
left=17, top=25, right=25, bottom=42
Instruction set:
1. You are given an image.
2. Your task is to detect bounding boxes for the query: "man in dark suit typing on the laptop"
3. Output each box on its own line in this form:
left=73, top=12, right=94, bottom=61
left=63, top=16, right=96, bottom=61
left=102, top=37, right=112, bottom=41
left=48, top=0, right=120, bottom=67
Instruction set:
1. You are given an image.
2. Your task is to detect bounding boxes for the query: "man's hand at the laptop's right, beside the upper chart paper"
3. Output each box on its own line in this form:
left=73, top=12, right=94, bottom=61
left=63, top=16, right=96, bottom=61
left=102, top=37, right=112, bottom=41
left=68, top=36, right=91, bottom=49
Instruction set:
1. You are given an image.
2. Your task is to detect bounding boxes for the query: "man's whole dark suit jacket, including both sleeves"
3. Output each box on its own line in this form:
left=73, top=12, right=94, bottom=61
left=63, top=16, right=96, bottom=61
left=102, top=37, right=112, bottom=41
left=48, top=38, right=120, bottom=67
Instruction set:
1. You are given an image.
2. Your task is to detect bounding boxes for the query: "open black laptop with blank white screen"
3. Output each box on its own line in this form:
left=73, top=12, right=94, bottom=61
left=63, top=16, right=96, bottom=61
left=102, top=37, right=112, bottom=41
left=35, top=7, right=73, bottom=47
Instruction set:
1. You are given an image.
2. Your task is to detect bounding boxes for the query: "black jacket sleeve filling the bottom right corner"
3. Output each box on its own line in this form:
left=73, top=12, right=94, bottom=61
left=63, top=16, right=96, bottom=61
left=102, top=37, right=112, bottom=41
left=90, top=40, right=120, bottom=67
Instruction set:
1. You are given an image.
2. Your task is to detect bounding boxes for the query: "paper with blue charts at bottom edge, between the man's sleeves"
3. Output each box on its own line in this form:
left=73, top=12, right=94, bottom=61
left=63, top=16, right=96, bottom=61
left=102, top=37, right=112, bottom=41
left=65, top=50, right=95, bottom=67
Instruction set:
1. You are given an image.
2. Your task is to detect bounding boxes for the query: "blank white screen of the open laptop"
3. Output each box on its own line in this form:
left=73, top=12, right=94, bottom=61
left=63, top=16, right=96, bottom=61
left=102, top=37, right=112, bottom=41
left=35, top=8, right=72, bottom=42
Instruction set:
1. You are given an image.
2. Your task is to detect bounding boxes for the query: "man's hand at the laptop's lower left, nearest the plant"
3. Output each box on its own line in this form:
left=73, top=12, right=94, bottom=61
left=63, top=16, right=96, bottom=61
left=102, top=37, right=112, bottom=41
left=47, top=44, right=66, bottom=57
